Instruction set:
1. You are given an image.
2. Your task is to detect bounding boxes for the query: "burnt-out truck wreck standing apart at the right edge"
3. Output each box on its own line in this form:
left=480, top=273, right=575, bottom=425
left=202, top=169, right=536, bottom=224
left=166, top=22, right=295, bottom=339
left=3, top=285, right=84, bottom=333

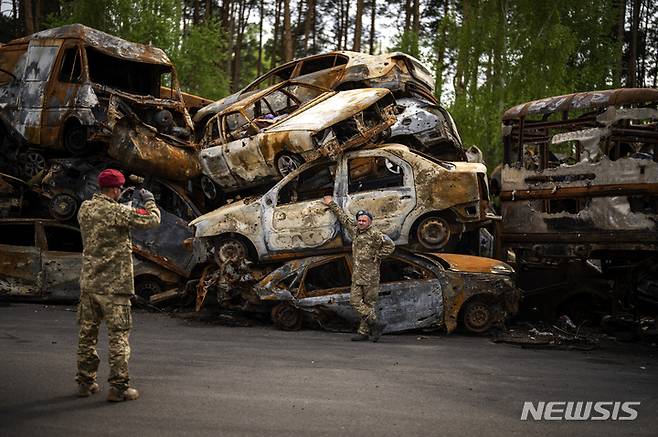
left=497, top=88, right=658, bottom=315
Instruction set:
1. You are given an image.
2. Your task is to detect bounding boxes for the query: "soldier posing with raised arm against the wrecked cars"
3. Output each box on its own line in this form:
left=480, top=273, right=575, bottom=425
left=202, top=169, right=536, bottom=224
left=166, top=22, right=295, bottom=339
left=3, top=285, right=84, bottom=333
left=323, top=196, right=395, bottom=342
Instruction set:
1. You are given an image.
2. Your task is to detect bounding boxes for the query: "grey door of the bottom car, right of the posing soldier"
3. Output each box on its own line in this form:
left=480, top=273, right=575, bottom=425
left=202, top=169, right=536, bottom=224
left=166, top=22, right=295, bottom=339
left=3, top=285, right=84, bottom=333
left=377, top=257, right=443, bottom=332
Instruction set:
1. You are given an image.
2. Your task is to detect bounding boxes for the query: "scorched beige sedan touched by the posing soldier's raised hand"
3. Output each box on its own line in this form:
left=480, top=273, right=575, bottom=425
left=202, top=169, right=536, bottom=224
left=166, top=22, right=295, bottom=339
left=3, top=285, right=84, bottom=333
left=190, top=144, right=490, bottom=261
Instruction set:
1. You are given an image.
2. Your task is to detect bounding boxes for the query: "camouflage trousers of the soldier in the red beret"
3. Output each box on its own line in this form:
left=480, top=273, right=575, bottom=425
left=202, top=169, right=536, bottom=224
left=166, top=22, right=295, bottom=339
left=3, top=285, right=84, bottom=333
left=75, top=293, right=132, bottom=391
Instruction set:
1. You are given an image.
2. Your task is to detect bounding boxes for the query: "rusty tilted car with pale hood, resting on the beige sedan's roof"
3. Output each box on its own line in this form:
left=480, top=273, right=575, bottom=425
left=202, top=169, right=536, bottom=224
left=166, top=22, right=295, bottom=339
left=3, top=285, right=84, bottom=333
left=199, top=82, right=395, bottom=198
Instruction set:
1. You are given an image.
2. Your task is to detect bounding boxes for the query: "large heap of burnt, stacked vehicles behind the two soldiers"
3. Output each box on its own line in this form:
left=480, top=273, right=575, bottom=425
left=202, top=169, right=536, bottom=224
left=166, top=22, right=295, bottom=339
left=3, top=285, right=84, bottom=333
left=0, top=25, right=520, bottom=332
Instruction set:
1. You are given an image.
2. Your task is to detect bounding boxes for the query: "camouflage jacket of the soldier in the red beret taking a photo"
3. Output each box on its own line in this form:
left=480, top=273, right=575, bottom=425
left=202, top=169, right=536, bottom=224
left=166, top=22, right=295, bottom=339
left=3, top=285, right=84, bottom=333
left=78, top=193, right=160, bottom=295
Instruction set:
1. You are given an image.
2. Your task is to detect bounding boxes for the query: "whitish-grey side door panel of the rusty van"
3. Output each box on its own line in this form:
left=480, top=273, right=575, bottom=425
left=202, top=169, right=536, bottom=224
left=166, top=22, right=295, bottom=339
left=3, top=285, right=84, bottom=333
left=17, top=39, right=61, bottom=144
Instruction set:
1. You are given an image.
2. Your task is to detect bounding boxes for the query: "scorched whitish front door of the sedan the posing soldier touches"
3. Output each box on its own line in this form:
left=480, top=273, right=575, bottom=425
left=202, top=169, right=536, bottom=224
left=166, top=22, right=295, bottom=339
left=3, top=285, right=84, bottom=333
left=262, top=162, right=342, bottom=252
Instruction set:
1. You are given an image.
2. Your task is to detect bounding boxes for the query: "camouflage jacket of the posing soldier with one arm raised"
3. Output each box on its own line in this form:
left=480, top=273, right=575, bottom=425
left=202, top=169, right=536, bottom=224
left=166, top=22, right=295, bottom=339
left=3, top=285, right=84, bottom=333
left=329, top=202, right=395, bottom=285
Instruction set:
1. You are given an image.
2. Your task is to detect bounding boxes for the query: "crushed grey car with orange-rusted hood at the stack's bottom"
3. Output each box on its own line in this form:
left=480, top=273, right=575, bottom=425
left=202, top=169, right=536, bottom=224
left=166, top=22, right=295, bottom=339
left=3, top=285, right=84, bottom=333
left=254, top=250, right=521, bottom=333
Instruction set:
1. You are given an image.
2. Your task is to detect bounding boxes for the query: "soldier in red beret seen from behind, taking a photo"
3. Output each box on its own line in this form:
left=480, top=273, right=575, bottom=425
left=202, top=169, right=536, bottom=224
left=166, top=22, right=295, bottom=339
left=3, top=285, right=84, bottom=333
left=76, top=169, right=160, bottom=402
